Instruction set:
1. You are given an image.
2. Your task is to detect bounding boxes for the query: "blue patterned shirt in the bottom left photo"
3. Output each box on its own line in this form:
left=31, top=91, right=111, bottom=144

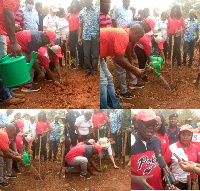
left=49, top=121, right=63, bottom=141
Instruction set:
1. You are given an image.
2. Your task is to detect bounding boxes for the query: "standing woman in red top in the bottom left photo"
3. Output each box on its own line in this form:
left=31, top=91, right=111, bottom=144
left=35, top=111, right=51, bottom=163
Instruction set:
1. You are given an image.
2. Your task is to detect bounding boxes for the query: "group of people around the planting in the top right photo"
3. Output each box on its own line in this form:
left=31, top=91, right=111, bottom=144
left=100, top=0, right=200, bottom=109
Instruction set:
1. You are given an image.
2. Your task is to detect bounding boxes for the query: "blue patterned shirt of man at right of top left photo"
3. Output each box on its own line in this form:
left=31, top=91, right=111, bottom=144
left=79, top=5, right=99, bottom=40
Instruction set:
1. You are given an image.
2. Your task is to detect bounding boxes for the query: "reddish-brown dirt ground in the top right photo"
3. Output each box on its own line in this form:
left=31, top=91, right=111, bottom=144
left=107, top=50, right=200, bottom=109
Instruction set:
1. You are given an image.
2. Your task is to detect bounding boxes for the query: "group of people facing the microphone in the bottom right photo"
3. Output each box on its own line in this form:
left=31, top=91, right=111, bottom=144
left=131, top=110, right=200, bottom=190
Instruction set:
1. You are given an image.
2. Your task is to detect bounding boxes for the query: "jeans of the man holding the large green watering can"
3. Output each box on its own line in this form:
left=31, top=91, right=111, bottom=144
left=0, top=34, right=13, bottom=104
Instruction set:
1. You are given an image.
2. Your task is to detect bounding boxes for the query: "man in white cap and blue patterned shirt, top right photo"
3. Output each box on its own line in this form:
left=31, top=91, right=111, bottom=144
left=183, top=9, right=199, bottom=68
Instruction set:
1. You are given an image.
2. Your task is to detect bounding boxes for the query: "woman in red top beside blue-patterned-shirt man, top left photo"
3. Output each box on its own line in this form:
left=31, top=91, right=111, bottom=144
left=66, top=0, right=84, bottom=71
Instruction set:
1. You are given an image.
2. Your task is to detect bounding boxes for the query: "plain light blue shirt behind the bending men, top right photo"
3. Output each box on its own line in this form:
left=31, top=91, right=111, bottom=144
left=112, top=6, right=133, bottom=28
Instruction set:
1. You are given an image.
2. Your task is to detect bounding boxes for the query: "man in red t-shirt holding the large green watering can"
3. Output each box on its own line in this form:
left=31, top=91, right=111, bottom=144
left=0, top=0, right=25, bottom=105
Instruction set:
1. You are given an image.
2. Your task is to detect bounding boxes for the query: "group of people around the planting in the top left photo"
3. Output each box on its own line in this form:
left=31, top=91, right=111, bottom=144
left=0, top=0, right=99, bottom=105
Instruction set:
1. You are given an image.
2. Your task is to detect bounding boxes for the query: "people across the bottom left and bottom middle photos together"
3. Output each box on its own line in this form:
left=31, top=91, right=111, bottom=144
left=0, top=109, right=132, bottom=187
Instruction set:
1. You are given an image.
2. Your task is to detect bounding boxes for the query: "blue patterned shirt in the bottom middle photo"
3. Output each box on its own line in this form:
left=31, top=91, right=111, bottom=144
left=109, top=109, right=122, bottom=134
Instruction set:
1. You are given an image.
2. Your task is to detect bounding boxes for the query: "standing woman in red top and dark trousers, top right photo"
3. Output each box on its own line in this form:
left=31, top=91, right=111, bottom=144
left=167, top=5, right=185, bottom=69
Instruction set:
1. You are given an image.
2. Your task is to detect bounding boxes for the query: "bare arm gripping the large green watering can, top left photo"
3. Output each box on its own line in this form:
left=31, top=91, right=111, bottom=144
left=3, top=8, right=22, bottom=56
